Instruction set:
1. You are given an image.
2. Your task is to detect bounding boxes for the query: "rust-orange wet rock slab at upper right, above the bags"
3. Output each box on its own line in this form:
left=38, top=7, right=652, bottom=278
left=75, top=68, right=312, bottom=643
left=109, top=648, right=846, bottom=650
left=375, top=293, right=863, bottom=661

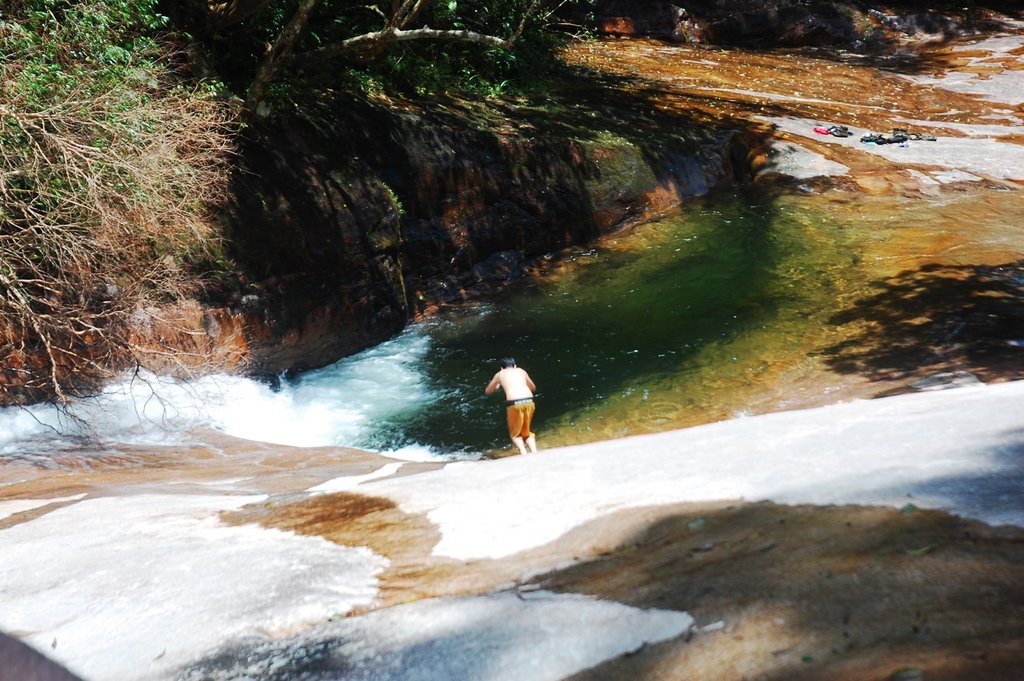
left=565, top=39, right=1022, bottom=193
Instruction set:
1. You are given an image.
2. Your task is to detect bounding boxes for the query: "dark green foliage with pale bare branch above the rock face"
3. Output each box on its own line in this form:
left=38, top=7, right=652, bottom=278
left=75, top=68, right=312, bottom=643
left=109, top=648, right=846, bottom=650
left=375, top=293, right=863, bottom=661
left=175, top=0, right=592, bottom=108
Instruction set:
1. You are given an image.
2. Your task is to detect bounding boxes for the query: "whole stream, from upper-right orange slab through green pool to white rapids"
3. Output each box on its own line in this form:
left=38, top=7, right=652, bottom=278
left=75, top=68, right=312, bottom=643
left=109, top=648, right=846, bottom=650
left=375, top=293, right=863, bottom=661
left=0, top=29, right=1024, bottom=458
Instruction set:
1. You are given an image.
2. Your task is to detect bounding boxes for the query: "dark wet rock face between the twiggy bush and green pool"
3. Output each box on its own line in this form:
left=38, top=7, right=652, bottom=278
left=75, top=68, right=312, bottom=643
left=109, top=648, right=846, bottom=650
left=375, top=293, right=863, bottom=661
left=209, top=93, right=750, bottom=373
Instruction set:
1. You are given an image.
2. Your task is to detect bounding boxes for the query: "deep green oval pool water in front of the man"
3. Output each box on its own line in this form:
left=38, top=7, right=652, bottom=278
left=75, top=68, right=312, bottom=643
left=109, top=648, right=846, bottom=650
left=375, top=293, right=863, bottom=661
left=356, top=184, right=865, bottom=452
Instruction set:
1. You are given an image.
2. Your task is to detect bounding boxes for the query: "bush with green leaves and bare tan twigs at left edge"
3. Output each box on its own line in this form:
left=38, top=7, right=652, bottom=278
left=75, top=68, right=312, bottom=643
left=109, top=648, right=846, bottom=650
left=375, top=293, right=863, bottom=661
left=0, top=0, right=231, bottom=398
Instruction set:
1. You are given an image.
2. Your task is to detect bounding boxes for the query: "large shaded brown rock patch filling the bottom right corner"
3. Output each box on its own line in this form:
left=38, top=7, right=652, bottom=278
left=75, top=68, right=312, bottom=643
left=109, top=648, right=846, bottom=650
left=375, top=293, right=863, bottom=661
left=538, top=503, right=1024, bottom=681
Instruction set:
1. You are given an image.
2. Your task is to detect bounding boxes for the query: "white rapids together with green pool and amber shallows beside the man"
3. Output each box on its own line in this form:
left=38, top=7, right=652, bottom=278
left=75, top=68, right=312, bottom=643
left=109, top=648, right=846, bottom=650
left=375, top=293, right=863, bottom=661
left=0, top=187, right=1024, bottom=459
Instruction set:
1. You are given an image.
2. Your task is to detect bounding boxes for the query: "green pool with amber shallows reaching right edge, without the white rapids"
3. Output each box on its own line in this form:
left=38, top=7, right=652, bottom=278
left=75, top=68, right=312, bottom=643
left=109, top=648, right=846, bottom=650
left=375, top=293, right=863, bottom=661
left=284, top=187, right=1024, bottom=453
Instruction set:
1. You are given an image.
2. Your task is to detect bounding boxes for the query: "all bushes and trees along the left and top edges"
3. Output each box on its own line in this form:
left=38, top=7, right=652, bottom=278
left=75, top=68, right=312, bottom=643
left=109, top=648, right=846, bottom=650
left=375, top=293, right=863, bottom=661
left=0, top=0, right=587, bottom=402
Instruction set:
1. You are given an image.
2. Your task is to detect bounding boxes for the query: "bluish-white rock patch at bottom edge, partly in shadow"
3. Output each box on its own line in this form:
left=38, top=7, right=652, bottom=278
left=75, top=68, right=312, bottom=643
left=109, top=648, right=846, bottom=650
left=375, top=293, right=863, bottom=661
left=177, top=590, right=685, bottom=681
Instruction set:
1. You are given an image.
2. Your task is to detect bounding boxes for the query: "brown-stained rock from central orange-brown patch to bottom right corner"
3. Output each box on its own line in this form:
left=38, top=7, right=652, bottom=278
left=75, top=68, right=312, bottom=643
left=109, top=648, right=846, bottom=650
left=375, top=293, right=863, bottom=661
left=225, top=494, right=1024, bottom=681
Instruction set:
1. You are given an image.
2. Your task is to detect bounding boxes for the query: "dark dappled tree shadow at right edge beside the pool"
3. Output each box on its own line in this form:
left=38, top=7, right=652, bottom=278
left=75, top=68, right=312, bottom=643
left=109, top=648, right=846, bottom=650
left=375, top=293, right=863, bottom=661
left=822, top=260, right=1024, bottom=387
